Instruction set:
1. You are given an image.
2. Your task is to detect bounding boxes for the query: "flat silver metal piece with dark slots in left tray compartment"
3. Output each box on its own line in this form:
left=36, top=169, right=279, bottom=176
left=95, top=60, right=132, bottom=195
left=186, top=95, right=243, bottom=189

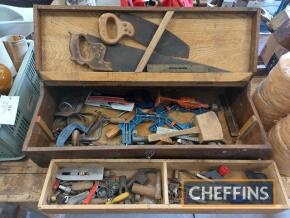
left=56, top=167, right=104, bottom=181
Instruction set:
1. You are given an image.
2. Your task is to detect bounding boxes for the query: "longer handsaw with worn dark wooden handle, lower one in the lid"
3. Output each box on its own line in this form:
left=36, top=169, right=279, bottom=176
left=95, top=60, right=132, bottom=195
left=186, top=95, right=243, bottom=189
left=70, top=33, right=225, bottom=72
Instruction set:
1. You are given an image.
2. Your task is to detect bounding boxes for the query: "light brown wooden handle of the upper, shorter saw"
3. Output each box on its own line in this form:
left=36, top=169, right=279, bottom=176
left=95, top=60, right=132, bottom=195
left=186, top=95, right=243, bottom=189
left=99, top=13, right=135, bottom=45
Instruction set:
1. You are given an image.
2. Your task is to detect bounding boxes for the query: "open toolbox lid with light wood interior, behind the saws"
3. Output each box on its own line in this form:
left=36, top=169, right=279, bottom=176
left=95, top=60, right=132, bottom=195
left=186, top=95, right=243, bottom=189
left=34, top=6, right=260, bottom=86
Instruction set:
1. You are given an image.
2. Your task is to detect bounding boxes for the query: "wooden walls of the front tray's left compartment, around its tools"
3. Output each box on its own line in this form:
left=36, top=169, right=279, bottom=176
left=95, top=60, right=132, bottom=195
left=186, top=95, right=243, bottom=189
left=38, top=159, right=168, bottom=213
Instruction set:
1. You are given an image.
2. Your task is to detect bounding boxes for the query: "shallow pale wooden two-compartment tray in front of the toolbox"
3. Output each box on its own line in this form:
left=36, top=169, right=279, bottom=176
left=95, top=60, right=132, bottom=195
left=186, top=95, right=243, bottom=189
left=38, top=159, right=288, bottom=214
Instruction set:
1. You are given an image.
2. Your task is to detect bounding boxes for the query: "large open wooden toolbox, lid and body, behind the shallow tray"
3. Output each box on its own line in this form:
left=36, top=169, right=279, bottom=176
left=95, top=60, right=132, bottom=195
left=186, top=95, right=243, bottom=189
left=23, top=6, right=271, bottom=166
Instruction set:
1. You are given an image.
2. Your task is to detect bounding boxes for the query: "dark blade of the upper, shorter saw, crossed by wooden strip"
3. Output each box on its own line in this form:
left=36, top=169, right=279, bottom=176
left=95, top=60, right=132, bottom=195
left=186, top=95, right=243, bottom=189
left=120, top=13, right=189, bottom=58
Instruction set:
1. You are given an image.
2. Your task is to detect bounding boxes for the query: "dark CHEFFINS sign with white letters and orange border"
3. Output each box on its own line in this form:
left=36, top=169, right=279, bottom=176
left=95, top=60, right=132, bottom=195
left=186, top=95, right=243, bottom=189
left=182, top=179, right=275, bottom=206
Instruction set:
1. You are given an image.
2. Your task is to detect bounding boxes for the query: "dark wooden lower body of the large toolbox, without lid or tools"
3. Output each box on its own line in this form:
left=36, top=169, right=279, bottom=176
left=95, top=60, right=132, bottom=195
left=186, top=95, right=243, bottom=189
left=23, top=85, right=271, bottom=166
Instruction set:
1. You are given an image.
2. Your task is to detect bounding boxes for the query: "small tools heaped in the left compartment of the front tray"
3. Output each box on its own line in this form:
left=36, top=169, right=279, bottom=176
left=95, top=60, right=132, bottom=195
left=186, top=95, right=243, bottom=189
left=48, top=167, right=162, bottom=205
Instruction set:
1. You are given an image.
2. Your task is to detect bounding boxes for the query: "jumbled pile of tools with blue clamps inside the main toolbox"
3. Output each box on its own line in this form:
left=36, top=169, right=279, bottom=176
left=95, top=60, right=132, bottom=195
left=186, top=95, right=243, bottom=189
left=52, top=90, right=224, bottom=147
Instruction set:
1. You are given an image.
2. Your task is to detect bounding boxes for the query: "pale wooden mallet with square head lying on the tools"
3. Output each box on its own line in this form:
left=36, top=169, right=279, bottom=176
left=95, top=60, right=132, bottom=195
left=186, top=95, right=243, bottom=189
left=148, top=111, right=223, bottom=142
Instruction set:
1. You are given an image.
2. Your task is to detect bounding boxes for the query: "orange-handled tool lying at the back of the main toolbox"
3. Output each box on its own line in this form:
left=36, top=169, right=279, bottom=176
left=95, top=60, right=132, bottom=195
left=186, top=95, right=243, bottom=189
left=155, top=96, right=209, bottom=109
